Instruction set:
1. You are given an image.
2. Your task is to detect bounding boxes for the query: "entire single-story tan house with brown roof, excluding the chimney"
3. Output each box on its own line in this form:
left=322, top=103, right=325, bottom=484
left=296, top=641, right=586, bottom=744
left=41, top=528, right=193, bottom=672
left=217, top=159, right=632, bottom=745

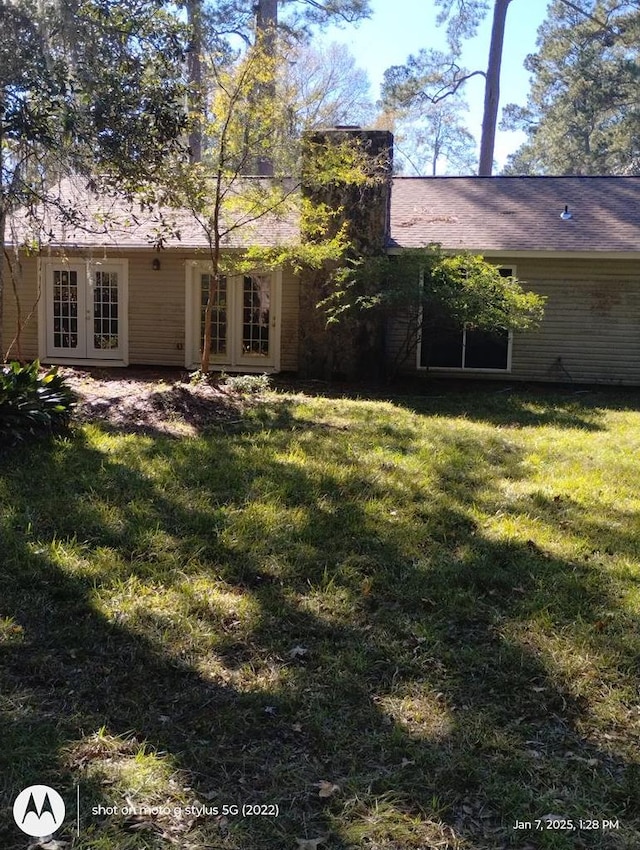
left=2, top=131, right=640, bottom=385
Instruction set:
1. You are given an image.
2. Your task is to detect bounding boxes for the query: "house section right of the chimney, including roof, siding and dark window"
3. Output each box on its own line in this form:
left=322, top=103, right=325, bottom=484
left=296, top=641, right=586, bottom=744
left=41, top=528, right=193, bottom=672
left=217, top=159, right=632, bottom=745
left=389, top=177, right=640, bottom=385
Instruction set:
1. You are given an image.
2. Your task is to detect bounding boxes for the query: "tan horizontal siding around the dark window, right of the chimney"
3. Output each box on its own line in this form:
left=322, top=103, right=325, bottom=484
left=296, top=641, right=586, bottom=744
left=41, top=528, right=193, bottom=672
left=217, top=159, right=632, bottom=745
left=388, top=257, right=640, bottom=385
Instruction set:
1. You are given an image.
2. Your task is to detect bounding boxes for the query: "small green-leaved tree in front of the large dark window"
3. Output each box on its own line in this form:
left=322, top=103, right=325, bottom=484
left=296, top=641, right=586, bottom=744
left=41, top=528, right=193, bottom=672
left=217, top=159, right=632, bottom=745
left=320, top=245, right=545, bottom=376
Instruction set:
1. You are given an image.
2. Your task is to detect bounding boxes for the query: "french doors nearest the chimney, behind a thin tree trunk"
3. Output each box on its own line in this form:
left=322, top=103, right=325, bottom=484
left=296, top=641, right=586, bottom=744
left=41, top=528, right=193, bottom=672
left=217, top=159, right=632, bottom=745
left=191, top=267, right=279, bottom=371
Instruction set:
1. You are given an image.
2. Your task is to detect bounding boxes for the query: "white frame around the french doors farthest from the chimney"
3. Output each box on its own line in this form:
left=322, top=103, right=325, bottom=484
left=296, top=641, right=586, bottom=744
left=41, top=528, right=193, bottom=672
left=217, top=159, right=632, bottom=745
left=38, top=257, right=129, bottom=366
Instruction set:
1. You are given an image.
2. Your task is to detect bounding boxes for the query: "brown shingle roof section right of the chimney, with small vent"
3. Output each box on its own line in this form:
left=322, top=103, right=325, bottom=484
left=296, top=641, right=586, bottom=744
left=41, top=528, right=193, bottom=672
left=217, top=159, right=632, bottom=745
left=390, top=177, right=640, bottom=252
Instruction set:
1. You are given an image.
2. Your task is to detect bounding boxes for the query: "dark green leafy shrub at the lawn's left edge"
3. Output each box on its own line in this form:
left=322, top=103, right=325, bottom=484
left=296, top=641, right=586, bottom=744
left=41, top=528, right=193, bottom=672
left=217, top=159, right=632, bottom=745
left=0, top=360, right=76, bottom=446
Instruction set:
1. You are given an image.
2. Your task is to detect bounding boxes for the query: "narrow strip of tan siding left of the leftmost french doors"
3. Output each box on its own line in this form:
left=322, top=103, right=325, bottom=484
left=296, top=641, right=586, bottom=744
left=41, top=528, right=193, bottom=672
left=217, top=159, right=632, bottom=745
left=2, top=252, right=38, bottom=360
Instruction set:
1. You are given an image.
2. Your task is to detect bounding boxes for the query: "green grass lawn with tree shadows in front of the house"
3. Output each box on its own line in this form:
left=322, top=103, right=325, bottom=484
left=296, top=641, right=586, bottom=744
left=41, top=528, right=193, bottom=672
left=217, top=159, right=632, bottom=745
left=0, top=384, right=640, bottom=850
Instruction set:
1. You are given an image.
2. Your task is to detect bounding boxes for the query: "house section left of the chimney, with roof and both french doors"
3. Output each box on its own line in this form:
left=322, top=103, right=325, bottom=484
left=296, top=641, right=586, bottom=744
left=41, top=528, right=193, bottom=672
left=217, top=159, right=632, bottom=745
left=2, top=181, right=299, bottom=372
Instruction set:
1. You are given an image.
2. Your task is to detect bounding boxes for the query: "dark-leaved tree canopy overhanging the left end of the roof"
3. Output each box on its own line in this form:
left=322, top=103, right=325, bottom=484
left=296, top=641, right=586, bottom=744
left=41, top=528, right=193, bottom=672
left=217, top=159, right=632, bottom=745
left=0, top=0, right=186, bottom=354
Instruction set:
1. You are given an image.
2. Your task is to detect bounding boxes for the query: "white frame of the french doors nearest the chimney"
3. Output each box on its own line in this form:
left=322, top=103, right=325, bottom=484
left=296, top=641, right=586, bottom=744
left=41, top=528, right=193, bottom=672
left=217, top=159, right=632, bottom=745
left=184, top=260, right=282, bottom=373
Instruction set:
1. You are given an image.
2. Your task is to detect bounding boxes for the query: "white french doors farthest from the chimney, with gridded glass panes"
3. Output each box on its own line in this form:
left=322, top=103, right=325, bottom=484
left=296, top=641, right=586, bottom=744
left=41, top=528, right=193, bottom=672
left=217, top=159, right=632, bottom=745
left=45, top=260, right=126, bottom=362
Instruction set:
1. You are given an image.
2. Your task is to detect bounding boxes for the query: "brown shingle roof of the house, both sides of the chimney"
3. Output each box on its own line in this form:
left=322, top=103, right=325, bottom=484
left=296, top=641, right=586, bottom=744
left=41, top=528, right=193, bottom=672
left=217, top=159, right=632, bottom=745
left=14, top=172, right=640, bottom=253
